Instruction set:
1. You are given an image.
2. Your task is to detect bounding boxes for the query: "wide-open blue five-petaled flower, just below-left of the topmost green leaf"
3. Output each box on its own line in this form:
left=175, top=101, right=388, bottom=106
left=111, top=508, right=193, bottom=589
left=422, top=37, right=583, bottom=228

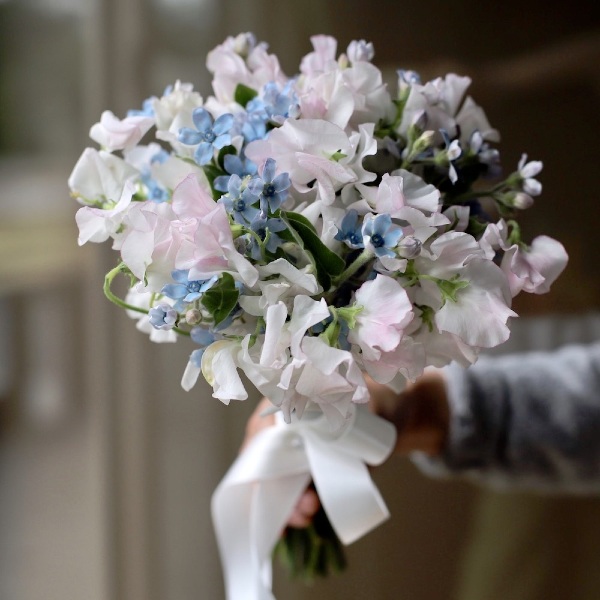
left=179, top=107, right=234, bottom=165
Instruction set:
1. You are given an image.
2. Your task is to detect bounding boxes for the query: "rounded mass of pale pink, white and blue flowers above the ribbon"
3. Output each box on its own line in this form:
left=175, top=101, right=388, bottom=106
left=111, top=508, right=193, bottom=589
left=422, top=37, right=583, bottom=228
left=69, top=34, right=567, bottom=596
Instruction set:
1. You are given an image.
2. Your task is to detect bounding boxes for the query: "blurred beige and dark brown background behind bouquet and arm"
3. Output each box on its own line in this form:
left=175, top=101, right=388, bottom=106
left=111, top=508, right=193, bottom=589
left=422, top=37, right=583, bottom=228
left=0, top=0, right=600, bottom=600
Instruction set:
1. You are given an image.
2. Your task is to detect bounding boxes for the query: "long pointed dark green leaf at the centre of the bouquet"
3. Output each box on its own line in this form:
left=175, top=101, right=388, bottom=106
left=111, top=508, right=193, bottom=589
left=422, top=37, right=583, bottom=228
left=280, top=212, right=346, bottom=291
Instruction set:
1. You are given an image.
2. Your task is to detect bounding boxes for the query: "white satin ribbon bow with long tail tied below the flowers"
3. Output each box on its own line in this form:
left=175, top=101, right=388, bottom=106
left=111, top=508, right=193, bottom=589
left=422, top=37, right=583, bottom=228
left=212, top=406, right=396, bottom=600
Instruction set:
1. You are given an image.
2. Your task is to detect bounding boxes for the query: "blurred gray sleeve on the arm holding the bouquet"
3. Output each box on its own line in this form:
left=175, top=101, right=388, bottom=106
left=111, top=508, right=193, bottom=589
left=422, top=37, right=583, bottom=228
left=414, top=343, right=600, bottom=493
